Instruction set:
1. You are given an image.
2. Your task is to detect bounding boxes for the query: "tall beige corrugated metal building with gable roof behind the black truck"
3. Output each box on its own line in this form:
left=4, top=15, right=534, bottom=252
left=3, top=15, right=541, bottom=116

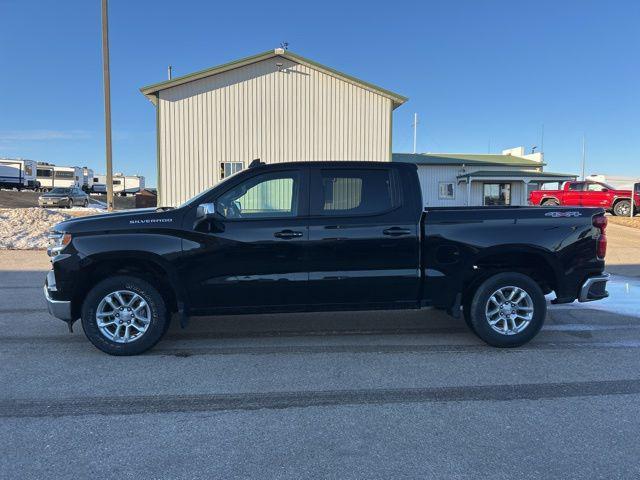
left=141, top=49, right=407, bottom=205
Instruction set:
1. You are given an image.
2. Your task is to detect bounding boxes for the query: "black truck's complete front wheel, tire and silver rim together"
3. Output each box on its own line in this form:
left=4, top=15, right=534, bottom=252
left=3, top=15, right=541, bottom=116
left=82, top=275, right=170, bottom=355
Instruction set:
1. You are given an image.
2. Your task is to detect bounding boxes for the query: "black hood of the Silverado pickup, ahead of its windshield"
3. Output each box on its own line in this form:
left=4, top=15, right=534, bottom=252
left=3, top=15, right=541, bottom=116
left=52, top=208, right=181, bottom=234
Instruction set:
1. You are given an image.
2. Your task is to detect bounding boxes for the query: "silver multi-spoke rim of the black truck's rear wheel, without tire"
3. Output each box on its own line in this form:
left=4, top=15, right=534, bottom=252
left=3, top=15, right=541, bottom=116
left=485, top=286, right=533, bottom=335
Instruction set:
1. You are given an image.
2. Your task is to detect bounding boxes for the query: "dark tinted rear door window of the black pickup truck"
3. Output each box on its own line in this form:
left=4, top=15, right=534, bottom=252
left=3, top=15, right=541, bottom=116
left=313, top=169, right=402, bottom=216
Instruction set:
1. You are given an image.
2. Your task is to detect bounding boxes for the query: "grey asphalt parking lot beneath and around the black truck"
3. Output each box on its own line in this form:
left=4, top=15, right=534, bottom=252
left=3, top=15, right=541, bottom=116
left=0, top=227, right=640, bottom=479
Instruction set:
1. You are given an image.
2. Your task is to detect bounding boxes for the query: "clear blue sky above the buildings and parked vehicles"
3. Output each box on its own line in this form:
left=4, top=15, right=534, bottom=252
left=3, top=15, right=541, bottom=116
left=0, top=0, right=640, bottom=185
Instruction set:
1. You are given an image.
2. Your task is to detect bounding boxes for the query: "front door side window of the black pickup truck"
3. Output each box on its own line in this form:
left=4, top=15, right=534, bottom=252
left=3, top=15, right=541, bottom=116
left=216, top=172, right=300, bottom=219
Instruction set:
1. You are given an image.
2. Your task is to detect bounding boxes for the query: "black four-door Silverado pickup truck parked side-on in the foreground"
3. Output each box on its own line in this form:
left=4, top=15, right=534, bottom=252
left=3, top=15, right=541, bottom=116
left=44, top=162, right=608, bottom=355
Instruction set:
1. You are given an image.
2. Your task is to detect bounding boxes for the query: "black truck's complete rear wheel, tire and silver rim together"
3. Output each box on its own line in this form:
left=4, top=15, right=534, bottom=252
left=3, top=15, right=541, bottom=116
left=468, top=272, right=547, bottom=347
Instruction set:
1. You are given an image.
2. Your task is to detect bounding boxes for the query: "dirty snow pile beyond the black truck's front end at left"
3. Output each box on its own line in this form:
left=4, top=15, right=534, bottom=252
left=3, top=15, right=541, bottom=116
left=0, top=208, right=72, bottom=250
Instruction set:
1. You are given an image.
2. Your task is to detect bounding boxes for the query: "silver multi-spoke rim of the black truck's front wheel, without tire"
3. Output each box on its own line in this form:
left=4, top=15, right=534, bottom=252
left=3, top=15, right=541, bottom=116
left=96, top=290, right=151, bottom=343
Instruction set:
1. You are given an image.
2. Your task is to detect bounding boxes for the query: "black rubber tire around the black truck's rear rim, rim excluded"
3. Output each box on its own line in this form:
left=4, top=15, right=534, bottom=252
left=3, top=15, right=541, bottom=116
left=469, top=272, right=547, bottom=348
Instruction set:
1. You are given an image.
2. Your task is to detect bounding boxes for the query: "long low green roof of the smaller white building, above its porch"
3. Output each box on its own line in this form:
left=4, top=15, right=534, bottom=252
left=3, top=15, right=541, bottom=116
left=392, top=153, right=546, bottom=167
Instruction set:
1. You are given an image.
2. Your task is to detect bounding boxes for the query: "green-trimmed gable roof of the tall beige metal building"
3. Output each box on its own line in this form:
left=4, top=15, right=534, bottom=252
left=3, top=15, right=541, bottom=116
left=140, top=48, right=408, bottom=108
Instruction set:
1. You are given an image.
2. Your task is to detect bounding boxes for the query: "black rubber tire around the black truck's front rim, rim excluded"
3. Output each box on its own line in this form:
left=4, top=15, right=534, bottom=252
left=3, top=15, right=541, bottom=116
left=82, top=275, right=171, bottom=355
